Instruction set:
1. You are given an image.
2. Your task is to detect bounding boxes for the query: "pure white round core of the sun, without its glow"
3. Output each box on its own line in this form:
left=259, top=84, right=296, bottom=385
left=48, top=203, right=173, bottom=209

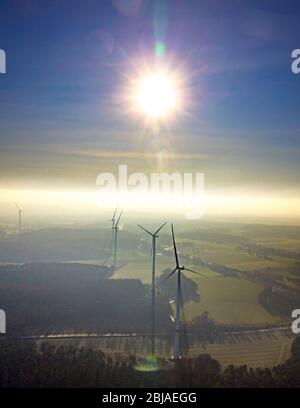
left=136, top=71, right=178, bottom=119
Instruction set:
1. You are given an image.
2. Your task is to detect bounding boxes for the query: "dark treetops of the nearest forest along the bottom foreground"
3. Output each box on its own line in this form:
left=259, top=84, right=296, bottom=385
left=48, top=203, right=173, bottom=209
left=0, top=337, right=300, bottom=388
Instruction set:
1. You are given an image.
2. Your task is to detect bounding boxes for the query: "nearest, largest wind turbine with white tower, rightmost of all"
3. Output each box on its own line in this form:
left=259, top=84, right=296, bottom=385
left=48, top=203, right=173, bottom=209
left=163, top=224, right=209, bottom=360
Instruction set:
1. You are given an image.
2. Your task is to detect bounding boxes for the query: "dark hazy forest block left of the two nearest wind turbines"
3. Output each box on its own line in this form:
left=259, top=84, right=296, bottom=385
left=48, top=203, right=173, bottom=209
left=0, top=263, right=170, bottom=336
